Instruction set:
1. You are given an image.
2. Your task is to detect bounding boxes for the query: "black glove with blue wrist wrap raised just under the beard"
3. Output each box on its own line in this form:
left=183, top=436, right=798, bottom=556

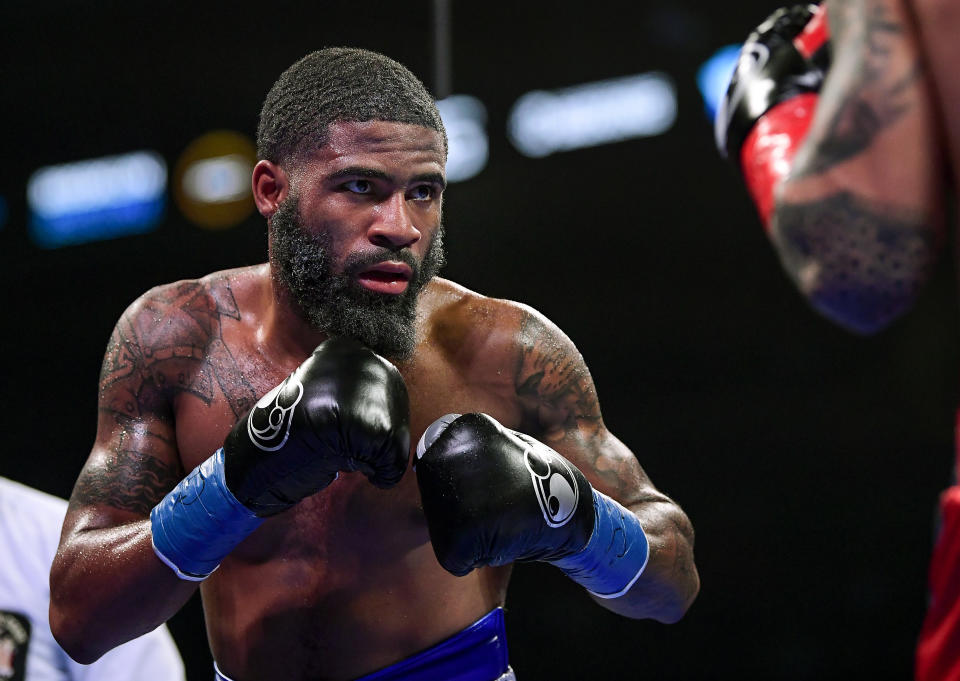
left=150, top=338, right=410, bottom=581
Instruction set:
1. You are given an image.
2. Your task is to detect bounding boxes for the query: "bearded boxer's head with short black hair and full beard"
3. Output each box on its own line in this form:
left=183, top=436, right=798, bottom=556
left=254, top=48, right=447, bottom=358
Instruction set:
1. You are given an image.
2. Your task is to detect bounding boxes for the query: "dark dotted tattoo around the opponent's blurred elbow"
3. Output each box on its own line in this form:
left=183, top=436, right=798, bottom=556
left=772, top=193, right=936, bottom=330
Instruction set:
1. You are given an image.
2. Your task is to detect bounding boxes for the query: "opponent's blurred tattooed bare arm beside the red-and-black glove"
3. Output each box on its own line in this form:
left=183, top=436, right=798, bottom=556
left=771, top=0, right=943, bottom=333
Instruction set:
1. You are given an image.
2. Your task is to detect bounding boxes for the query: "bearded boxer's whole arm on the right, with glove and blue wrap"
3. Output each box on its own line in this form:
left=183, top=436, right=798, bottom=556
left=417, top=311, right=699, bottom=622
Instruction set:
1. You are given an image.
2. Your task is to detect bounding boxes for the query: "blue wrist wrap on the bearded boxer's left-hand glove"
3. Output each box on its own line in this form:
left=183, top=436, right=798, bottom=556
left=150, top=447, right=263, bottom=582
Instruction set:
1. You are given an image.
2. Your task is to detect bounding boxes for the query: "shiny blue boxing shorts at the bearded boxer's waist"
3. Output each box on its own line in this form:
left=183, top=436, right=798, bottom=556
left=214, top=608, right=517, bottom=681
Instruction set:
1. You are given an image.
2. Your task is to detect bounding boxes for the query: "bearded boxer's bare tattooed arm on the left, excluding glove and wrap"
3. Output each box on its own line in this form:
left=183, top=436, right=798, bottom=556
left=50, top=296, right=196, bottom=663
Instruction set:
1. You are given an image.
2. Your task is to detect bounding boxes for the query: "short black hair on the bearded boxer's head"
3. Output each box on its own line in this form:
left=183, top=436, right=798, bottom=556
left=257, top=47, right=447, bottom=165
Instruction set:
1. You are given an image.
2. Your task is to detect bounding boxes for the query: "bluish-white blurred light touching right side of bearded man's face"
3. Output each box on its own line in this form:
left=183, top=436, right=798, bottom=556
left=437, top=95, right=490, bottom=182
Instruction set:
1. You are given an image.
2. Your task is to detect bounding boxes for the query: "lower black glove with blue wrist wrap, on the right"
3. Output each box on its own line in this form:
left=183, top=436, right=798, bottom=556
left=416, top=414, right=649, bottom=598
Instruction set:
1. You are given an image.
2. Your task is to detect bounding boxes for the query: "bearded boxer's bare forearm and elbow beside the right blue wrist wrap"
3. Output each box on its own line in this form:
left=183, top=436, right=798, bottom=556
left=593, top=495, right=700, bottom=624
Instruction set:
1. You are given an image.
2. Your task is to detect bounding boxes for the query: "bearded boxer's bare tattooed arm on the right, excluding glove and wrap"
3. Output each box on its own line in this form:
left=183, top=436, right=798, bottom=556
left=516, top=311, right=700, bottom=622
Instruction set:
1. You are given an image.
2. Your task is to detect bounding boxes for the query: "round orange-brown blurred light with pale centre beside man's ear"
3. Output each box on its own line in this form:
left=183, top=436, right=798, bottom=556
left=173, top=130, right=257, bottom=229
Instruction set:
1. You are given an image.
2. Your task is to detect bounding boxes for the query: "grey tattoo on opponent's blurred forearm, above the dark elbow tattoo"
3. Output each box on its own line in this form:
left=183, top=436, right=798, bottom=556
left=792, top=0, right=922, bottom=178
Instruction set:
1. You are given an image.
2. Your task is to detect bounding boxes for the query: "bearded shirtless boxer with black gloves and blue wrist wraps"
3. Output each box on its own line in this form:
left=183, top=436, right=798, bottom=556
left=50, top=48, right=699, bottom=681
